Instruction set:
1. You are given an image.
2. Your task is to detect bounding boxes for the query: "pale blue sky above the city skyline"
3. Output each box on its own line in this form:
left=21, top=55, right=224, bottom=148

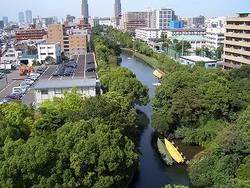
left=0, top=0, right=250, bottom=21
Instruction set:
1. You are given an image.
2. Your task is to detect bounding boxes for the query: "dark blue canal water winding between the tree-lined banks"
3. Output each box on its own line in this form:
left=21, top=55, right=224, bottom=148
left=121, top=54, right=190, bottom=188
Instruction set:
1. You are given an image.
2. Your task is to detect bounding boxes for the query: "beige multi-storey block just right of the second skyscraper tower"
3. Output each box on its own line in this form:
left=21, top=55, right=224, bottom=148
left=121, top=12, right=147, bottom=33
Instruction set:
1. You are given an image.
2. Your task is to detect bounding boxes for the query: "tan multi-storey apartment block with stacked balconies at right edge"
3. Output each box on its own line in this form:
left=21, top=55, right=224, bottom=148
left=223, top=12, right=250, bottom=68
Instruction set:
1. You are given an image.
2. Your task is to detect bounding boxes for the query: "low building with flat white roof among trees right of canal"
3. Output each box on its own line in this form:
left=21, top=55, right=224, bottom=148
left=180, top=56, right=217, bottom=68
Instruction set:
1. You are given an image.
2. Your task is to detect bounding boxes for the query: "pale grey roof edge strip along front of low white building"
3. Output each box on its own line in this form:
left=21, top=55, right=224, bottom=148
left=34, top=79, right=96, bottom=90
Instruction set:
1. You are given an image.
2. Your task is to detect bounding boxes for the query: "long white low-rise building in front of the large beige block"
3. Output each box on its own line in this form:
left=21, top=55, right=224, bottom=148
left=135, top=28, right=162, bottom=42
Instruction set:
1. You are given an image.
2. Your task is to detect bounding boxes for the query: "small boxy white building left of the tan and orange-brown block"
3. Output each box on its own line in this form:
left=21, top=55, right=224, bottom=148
left=37, top=42, right=62, bottom=64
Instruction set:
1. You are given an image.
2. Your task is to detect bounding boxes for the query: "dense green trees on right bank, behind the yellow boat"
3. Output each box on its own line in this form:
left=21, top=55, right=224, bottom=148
left=153, top=66, right=250, bottom=187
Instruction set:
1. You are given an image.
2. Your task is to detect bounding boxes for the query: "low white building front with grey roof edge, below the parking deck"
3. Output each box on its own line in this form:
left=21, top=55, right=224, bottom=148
left=34, top=78, right=97, bottom=106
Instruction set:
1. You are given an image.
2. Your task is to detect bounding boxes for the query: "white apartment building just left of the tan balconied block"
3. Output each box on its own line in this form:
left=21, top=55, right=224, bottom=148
left=206, top=28, right=225, bottom=49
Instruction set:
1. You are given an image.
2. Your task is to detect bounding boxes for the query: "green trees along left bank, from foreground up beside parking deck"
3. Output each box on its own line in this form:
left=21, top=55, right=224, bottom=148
left=0, top=26, right=149, bottom=188
